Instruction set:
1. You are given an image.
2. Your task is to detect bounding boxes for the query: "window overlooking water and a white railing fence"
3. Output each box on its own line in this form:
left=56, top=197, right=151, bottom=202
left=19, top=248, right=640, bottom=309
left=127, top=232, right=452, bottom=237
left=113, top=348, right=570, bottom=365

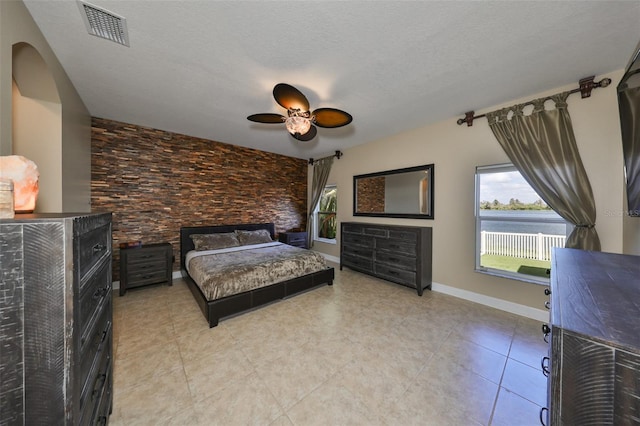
left=476, top=164, right=568, bottom=283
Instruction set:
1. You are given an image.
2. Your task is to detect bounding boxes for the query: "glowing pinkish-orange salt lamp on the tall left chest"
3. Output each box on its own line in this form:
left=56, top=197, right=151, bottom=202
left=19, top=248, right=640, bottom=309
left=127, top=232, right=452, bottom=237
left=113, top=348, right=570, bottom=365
left=0, top=155, right=40, bottom=213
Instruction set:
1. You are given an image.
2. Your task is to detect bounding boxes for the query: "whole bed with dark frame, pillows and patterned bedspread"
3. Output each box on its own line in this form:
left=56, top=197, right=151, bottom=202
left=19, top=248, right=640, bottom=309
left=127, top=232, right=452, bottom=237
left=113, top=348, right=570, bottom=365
left=180, top=223, right=334, bottom=327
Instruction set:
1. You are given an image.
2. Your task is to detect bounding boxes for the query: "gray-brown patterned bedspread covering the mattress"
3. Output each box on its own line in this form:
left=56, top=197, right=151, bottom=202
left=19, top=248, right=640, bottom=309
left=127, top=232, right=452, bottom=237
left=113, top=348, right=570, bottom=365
left=186, top=242, right=327, bottom=300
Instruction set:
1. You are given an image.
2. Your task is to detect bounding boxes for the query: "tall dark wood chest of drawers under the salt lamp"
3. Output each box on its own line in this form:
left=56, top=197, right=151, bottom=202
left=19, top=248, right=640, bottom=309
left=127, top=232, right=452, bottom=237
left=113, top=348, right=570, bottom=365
left=0, top=213, right=113, bottom=425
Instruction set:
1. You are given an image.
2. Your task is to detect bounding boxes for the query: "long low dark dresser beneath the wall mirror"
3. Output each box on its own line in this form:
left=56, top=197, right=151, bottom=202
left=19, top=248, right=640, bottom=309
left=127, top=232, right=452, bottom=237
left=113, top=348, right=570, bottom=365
left=340, top=222, right=432, bottom=296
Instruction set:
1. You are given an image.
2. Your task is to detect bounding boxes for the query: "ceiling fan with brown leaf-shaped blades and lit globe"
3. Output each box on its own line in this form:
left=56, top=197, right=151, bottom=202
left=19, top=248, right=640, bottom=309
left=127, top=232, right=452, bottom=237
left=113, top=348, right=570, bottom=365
left=247, top=83, right=353, bottom=142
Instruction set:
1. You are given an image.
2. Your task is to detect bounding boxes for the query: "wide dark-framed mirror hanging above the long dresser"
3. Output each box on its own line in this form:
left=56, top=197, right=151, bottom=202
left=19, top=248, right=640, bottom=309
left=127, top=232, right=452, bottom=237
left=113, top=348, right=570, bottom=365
left=353, top=164, right=434, bottom=219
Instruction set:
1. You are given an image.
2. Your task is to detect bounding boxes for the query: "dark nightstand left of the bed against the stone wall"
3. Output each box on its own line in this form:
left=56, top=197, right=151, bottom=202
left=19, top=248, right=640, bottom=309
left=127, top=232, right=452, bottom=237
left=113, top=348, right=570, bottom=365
left=120, top=243, right=173, bottom=296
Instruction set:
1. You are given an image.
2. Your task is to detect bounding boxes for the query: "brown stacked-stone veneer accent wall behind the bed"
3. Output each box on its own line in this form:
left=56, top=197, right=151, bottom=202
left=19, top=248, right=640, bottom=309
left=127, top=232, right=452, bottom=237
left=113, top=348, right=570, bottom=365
left=91, top=118, right=308, bottom=280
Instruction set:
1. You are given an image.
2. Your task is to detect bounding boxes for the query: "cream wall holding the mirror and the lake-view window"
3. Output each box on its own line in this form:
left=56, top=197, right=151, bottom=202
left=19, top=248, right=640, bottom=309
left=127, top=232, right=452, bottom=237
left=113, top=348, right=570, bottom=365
left=314, top=70, right=637, bottom=308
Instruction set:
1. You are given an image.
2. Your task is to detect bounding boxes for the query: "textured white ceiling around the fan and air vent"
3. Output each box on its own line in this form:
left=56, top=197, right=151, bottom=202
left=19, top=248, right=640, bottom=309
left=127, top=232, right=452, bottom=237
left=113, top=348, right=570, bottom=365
left=25, top=0, right=640, bottom=158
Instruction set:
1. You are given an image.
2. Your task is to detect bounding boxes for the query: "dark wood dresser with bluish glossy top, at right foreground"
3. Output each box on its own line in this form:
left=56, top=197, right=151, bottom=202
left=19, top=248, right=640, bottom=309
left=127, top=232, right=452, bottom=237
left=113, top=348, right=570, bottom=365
left=540, top=249, right=640, bottom=426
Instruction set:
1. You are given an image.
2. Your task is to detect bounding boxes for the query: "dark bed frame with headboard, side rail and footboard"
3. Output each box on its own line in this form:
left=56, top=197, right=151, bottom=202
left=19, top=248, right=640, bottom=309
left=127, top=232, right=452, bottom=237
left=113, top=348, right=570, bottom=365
left=180, top=223, right=335, bottom=327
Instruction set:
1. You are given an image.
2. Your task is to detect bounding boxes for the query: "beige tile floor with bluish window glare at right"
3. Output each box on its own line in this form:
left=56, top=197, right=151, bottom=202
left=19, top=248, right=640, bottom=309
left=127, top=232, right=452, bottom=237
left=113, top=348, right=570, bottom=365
left=110, top=267, right=546, bottom=426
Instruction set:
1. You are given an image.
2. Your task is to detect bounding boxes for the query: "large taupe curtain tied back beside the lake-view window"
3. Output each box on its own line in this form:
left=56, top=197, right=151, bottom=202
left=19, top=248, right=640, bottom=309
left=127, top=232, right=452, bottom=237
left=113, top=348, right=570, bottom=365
left=487, top=92, right=600, bottom=251
